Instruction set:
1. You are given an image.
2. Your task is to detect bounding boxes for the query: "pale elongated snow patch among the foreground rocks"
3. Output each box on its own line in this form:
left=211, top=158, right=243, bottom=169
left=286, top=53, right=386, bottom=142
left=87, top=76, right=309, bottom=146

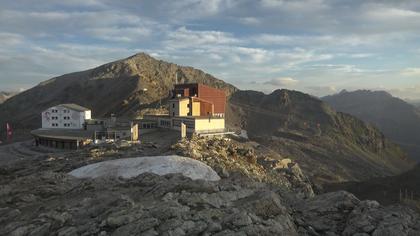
left=69, top=155, right=220, bottom=181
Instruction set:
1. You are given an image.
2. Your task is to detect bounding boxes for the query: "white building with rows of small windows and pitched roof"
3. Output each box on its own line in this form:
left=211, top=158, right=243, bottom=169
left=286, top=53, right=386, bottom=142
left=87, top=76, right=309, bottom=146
left=42, top=104, right=91, bottom=129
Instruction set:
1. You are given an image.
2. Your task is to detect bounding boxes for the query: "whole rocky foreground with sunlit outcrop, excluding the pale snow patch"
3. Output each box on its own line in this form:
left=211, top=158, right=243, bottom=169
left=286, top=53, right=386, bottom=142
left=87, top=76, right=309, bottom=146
left=0, top=136, right=420, bottom=236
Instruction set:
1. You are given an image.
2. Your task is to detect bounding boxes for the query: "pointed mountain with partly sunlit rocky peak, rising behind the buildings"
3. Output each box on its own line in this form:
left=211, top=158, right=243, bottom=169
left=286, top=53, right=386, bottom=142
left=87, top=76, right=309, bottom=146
left=0, top=53, right=236, bottom=131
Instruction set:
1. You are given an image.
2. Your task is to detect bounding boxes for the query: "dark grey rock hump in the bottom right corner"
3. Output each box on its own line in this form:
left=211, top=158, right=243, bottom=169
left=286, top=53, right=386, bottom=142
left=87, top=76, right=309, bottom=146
left=294, top=191, right=420, bottom=236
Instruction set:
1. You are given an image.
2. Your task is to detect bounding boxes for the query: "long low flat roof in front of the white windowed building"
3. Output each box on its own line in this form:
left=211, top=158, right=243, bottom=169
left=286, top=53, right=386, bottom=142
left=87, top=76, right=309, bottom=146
left=31, top=129, right=93, bottom=140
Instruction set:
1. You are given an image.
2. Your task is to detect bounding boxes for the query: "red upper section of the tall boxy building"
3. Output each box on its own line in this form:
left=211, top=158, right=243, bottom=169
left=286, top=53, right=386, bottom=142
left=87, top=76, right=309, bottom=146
left=174, top=83, right=226, bottom=116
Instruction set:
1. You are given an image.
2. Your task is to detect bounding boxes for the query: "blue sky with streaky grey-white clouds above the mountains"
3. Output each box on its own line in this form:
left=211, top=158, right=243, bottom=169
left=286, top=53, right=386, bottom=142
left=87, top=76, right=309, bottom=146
left=0, top=0, right=420, bottom=99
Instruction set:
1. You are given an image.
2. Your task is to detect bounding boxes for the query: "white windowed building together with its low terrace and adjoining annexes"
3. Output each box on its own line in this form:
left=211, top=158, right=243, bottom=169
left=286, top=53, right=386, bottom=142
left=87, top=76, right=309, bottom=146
left=31, top=103, right=138, bottom=149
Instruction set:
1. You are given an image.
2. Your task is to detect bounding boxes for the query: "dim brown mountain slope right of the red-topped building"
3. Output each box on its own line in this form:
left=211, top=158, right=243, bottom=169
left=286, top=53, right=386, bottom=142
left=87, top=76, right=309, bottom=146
left=227, top=90, right=411, bottom=183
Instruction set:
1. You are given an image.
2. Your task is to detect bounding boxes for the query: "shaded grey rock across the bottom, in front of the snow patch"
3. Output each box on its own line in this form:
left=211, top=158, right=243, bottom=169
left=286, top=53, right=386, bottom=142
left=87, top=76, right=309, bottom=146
left=0, top=170, right=420, bottom=235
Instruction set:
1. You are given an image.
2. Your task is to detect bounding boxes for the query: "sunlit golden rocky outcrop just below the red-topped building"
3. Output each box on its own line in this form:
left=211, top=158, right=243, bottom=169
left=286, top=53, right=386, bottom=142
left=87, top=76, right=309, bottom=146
left=172, top=136, right=314, bottom=198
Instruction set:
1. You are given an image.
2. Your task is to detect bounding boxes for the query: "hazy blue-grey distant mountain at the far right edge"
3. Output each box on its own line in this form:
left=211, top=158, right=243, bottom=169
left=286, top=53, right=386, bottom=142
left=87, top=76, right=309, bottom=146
left=322, top=90, right=420, bottom=160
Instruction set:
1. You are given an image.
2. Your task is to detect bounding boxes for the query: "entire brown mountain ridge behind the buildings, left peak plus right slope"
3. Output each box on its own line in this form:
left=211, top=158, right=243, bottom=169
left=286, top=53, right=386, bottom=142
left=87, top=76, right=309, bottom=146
left=0, top=53, right=412, bottom=183
